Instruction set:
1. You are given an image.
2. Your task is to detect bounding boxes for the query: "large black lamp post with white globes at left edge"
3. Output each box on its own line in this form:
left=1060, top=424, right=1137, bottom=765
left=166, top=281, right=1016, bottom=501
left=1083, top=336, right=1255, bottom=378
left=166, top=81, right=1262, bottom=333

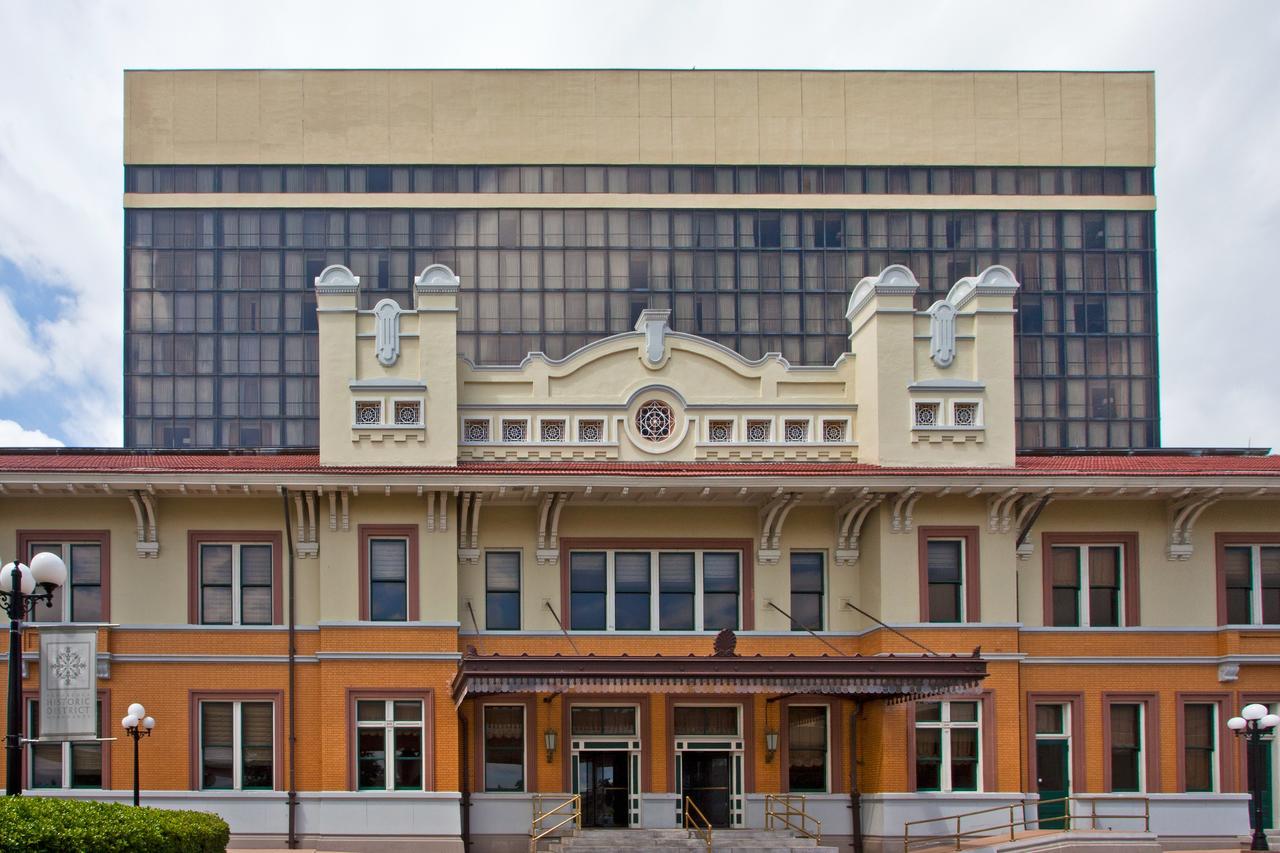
left=0, top=551, right=67, bottom=797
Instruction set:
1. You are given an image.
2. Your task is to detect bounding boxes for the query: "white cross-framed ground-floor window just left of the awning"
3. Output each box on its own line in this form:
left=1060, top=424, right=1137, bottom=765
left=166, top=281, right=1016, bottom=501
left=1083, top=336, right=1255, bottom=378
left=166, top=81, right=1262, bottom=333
left=356, top=699, right=426, bottom=790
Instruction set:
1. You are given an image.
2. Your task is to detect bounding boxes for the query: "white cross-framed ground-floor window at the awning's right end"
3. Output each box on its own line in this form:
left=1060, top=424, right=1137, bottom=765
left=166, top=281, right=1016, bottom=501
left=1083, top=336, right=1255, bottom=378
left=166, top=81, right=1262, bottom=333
left=915, top=701, right=982, bottom=792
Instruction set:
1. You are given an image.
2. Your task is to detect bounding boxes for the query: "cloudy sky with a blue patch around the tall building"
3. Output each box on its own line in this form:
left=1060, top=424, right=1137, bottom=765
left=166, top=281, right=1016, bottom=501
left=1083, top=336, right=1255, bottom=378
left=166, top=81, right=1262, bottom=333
left=0, top=0, right=1280, bottom=448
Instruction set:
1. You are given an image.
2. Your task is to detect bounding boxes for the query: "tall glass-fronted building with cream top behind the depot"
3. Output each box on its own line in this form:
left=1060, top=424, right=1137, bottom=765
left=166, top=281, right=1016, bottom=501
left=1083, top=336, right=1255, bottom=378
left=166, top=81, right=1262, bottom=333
left=124, top=70, right=1160, bottom=450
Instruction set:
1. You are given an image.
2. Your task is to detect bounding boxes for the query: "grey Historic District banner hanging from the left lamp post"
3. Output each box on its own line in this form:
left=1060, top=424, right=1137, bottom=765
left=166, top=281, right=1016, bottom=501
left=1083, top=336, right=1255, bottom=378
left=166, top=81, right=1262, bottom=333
left=40, top=628, right=97, bottom=740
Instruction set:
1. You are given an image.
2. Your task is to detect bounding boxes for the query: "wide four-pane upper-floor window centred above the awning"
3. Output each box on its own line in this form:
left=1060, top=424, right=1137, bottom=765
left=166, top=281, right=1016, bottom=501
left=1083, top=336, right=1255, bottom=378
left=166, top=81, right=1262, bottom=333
left=568, top=551, right=742, bottom=631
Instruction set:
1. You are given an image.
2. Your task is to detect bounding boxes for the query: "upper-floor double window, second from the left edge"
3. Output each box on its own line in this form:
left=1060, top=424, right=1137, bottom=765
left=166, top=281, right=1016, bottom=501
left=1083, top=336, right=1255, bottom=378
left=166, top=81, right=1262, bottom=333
left=200, top=543, right=274, bottom=625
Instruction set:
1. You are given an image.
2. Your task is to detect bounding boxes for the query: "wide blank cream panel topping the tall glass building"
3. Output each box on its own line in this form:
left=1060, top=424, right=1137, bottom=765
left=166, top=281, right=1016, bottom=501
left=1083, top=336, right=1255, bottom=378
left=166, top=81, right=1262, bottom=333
left=124, top=70, right=1155, bottom=167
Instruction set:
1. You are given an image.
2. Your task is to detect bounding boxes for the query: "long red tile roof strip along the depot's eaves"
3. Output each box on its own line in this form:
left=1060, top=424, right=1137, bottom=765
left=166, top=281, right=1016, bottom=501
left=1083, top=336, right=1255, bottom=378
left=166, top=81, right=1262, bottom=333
left=0, top=450, right=1280, bottom=476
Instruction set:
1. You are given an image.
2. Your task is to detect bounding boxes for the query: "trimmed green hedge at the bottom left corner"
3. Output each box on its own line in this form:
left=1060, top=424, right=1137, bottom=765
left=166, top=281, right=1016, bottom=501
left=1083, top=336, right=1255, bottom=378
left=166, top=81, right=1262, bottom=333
left=0, top=797, right=230, bottom=853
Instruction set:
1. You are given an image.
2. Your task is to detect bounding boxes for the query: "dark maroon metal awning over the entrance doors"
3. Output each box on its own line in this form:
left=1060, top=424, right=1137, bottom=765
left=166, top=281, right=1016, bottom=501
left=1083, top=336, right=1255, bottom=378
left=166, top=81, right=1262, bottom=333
left=453, top=652, right=987, bottom=704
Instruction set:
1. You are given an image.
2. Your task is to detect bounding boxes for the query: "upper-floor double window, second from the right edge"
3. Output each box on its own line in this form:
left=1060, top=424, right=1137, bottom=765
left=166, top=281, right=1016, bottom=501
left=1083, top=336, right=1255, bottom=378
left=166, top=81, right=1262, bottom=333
left=1050, top=544, right=1124, bottom=628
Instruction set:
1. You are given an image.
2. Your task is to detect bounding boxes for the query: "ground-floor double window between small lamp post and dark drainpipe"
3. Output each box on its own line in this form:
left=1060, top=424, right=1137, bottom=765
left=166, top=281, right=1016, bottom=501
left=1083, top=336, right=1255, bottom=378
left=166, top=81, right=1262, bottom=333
left=200, top=702, right=275, bottom=790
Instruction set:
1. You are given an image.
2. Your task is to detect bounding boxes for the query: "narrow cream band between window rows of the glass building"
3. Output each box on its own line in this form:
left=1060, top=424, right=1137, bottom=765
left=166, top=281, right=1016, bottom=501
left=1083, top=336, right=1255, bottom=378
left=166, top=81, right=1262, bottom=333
left=124, top=192, right=1156, bottom=211
